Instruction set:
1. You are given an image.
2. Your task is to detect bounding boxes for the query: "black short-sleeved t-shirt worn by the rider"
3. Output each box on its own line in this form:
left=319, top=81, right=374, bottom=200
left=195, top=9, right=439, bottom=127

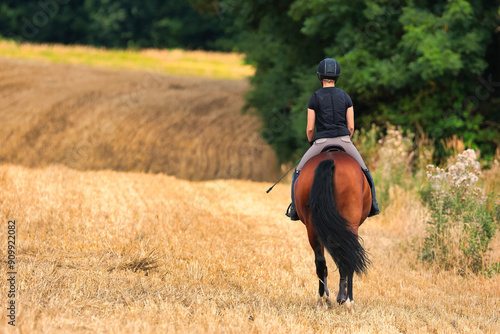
left=307, top=87, right=352, bottom=140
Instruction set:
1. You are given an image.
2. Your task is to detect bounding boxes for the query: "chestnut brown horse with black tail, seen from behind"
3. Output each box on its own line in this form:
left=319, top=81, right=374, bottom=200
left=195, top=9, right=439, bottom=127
left=294, top=151, right=372, bottom=312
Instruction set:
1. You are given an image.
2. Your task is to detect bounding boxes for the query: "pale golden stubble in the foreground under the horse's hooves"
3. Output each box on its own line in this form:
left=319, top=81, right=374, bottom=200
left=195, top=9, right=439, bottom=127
left=0, top=165, right=500, bottom=333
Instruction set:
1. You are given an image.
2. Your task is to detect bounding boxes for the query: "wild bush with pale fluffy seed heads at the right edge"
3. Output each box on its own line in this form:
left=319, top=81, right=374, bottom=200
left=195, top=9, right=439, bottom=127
left=421, top=149, right=500, bottom=274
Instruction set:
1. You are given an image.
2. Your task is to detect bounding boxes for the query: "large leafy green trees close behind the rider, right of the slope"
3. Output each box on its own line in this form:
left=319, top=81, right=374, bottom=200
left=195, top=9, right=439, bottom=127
left=219, top=0, right=500, bottom=160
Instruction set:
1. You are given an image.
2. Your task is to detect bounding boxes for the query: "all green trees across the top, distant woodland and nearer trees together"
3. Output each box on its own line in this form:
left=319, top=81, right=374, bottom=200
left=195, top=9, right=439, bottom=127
left=0, top=0, right=500, bottom=161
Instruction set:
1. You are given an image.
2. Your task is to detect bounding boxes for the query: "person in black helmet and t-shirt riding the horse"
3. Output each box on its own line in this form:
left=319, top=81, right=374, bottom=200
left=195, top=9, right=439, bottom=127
left=286, top=58, right=380, bottom=220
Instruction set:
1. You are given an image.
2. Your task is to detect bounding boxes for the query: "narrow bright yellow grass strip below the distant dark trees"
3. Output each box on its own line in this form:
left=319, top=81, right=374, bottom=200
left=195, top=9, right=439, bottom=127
left=0, top=40, right=255, bottom=80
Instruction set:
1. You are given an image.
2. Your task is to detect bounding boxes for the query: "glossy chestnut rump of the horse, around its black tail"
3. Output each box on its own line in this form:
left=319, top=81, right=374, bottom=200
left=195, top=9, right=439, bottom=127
left=295, top=151, right=371, bottom=230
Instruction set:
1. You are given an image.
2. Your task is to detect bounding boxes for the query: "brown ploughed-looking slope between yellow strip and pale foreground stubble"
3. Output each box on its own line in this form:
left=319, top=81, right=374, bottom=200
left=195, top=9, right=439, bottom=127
left=0, top=58, right=279, bottom=181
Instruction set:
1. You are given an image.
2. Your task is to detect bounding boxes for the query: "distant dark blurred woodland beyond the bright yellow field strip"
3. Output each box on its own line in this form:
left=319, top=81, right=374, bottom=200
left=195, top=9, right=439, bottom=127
left=0, top=0, right=231, bottom=50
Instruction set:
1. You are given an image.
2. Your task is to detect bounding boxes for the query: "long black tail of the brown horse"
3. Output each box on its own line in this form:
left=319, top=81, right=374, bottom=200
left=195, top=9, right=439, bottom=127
left=309, top=159, right=370, bottom=275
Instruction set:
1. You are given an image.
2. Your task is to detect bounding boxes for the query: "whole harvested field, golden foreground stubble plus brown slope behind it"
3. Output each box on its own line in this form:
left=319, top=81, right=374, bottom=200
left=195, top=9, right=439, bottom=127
left=0, top=52, right=500, bottom=333
